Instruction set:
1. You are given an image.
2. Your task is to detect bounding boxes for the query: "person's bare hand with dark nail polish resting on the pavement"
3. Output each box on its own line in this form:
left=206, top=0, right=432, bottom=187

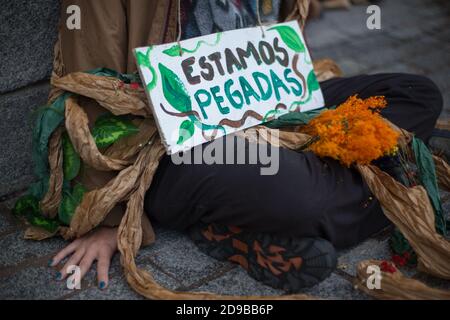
left=49, top=227, right=117, bottom=289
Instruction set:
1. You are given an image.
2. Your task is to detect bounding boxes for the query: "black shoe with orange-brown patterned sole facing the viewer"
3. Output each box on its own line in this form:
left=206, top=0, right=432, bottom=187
left=190, top=224, right=337, bottom=292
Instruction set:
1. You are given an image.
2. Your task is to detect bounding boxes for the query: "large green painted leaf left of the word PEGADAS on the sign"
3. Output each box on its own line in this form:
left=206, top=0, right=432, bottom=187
left=158, top=63, right=192, bottom=112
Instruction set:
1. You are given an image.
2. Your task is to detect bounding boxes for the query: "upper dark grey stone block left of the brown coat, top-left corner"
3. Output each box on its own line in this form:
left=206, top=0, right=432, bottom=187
left=0, top=0, right=60, bottom=93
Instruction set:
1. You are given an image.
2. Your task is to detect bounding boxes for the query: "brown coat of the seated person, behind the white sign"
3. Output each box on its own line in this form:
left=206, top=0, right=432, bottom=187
left=54, top=0, right=294, bottom=245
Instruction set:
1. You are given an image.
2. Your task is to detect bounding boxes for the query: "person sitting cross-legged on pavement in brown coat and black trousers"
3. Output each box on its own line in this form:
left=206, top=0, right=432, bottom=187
left=50, top=0, right=443, bottom=292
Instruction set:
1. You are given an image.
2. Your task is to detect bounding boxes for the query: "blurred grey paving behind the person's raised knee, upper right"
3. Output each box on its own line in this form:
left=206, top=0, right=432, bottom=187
left=306, top=0, right=450, bottom=119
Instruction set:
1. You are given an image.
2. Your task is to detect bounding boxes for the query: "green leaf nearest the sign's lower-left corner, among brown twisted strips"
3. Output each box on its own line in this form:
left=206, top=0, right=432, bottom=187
left=92, top=113, right=139, bottom=148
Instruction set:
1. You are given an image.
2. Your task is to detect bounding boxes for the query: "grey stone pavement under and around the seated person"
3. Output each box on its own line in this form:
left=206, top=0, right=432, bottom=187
left=0, top=0, right=450, bottom=299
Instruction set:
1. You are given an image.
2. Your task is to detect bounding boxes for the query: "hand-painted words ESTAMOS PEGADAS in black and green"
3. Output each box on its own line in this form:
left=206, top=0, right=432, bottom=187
left=181, top=37, right=304, bottom=119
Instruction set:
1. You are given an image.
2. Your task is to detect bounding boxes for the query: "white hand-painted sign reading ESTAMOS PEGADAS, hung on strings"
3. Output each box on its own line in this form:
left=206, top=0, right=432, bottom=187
left=134, top=21, right=324, bottom=154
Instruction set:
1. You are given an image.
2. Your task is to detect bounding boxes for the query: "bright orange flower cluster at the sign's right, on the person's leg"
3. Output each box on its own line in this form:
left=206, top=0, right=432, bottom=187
left=302, top=96, right=399, bottom=166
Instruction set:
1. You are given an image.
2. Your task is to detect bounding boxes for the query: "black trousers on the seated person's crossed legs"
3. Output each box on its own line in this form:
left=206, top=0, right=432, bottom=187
left=145, top=74, right=443, bottom=248
